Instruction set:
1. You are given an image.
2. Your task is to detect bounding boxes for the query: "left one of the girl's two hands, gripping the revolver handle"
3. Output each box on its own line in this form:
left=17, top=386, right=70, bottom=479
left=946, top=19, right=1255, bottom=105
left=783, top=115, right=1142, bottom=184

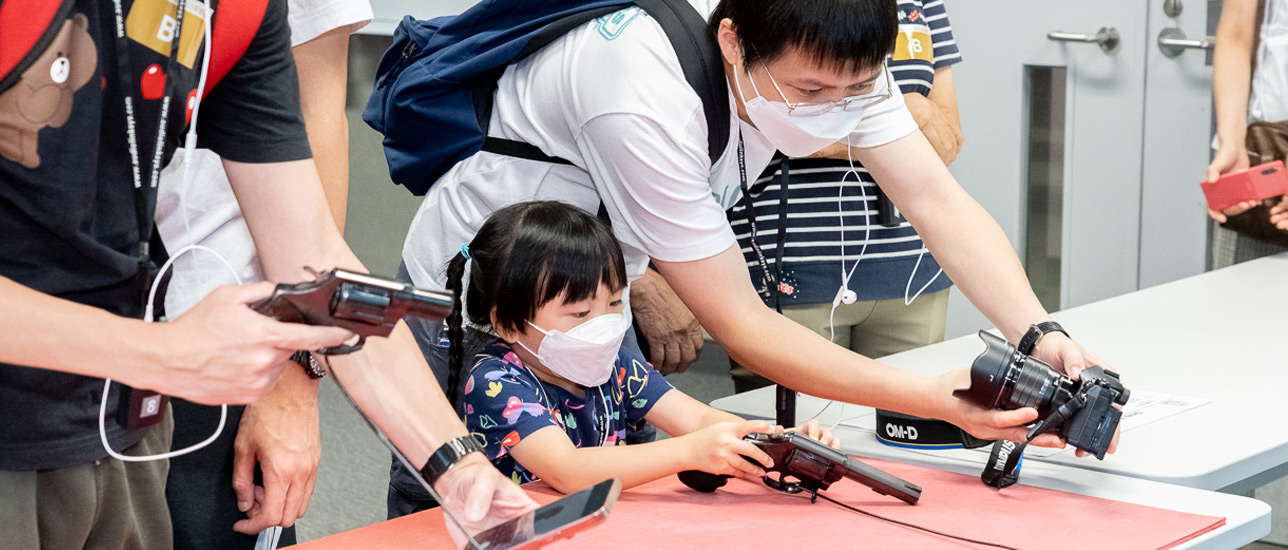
left=685, top=420, right=774, bottom=480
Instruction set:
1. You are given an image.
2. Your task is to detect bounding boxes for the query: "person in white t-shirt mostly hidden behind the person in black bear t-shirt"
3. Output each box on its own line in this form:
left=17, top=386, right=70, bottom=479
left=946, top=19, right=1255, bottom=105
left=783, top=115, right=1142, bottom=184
left=156, top=0, right=372, bottom=550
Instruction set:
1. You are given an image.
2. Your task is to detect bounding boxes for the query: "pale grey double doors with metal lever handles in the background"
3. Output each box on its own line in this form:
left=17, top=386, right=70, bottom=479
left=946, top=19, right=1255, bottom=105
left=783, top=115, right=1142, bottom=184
left=945, top=0, right=1218, bottom=336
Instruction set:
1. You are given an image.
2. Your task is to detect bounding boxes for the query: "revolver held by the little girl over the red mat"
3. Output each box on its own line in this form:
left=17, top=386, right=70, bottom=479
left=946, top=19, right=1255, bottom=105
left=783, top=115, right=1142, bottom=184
left=679, top=431, right=921, bottom=504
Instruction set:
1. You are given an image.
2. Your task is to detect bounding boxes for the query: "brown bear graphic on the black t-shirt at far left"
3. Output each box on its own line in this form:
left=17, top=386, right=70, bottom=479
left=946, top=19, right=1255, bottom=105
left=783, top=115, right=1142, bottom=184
left=0, top=13, right=98, bottom=169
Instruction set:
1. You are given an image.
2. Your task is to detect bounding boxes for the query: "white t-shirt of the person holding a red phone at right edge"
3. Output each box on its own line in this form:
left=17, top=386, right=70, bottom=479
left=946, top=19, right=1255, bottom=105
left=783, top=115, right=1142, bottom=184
left=1248, top=0, right=1288, bottom=122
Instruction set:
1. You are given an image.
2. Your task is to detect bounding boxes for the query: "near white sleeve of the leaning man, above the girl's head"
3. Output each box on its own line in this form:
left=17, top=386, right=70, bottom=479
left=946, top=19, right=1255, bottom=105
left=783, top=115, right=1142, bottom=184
left=576, top=112, right=734, bottom=261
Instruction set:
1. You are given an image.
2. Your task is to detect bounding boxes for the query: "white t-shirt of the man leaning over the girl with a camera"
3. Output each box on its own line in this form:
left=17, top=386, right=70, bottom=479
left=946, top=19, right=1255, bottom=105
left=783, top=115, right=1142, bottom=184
left=403, top=0, right=917, bottom=289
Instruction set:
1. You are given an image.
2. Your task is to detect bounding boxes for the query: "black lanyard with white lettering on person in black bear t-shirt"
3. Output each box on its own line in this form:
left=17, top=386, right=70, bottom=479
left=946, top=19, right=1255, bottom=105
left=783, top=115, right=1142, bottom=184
left=112, top=0, right=187, bottom=266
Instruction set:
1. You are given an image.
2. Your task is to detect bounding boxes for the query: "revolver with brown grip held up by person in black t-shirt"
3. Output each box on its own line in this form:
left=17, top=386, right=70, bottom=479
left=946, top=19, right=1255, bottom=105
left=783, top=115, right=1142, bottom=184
left=250, top=268, right=452, bottom=356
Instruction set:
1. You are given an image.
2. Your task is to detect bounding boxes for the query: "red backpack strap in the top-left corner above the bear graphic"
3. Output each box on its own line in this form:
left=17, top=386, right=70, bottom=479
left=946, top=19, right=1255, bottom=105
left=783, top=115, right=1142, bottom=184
left=0, top=0, right=75, bottom=93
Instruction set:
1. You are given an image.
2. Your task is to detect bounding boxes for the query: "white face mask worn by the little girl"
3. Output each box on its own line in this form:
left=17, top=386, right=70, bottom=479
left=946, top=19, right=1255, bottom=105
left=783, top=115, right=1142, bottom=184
left=519, top=313, right=630, bottom=388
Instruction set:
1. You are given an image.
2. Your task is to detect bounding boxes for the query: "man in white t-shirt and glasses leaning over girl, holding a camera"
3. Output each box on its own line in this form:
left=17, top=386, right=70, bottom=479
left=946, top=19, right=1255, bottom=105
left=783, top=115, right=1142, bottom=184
left=403, top=0, right=1117, bottom=517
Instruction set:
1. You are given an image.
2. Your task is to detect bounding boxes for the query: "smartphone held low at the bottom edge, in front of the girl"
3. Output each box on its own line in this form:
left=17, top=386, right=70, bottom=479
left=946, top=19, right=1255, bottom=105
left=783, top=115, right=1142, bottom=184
left=465, top=479, right=622, bottom=550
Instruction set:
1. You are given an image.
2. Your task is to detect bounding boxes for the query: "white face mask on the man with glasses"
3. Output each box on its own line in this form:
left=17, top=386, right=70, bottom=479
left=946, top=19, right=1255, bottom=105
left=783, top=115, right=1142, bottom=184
left=733, top=66, right=863, bottom=157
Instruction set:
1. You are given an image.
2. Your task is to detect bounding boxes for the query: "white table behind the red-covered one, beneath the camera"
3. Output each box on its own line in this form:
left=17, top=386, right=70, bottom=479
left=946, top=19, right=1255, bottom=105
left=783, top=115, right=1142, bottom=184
left=712, top=254, right=1288, bottom=493
